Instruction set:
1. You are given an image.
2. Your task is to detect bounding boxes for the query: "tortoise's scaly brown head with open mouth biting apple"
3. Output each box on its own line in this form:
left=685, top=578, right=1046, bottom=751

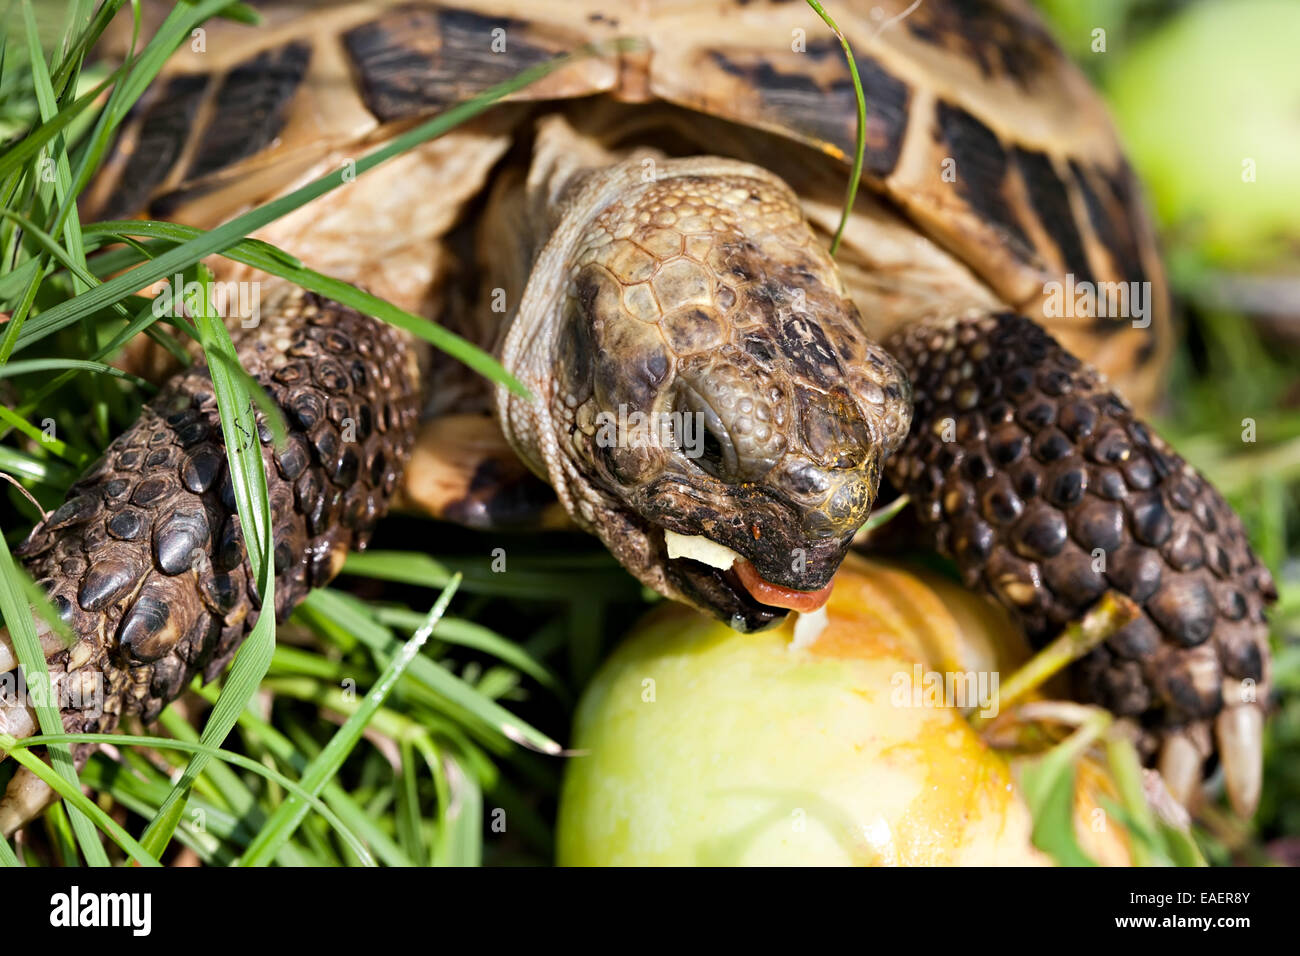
left=512, top=160, right=910, bottom=631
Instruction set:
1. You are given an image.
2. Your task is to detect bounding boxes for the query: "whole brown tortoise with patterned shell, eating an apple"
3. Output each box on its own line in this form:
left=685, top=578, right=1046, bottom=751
left=0, top=0, right=1275, bottom=831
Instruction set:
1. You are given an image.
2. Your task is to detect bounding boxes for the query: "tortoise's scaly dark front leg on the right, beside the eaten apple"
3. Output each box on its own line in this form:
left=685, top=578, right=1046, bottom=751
left=887, top=313, right=1277, bottom=817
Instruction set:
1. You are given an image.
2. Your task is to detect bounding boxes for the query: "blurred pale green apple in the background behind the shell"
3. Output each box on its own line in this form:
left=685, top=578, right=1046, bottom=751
left=1105, top=0, right=1300, bottom=271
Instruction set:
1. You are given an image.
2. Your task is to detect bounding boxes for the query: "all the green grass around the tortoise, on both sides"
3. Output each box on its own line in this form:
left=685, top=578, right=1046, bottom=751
left=0, top=0, right=1300, bottom=865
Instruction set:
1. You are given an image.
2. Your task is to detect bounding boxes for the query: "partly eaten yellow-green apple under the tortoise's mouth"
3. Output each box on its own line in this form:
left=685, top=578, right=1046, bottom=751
left=556, top=557, right=1066, bottom=865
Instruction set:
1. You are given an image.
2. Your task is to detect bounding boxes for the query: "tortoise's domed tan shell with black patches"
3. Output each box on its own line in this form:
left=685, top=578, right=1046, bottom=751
left=87, top=0, right=1171, bottom=408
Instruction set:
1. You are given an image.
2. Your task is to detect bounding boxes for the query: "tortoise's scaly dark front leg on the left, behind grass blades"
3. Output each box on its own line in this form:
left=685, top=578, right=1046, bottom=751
left=0, top=289, right=420, bottom=832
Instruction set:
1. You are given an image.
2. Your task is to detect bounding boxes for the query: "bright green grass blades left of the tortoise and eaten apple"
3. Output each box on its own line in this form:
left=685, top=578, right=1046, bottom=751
left=0, top=0, right=638, bottom=865
